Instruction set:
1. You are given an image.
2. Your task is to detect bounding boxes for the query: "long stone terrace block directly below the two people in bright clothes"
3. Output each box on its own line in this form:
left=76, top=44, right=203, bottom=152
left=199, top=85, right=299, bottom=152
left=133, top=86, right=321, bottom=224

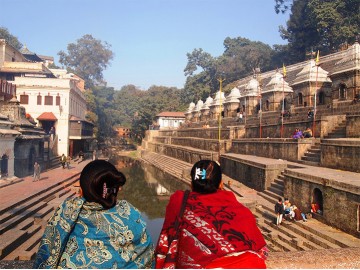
left=231, top=138, right=314, bottom=162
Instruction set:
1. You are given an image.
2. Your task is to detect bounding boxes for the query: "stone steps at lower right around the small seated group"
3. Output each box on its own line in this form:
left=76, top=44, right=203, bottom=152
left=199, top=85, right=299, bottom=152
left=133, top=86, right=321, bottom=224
left=254, top=173, right=360, bottom=252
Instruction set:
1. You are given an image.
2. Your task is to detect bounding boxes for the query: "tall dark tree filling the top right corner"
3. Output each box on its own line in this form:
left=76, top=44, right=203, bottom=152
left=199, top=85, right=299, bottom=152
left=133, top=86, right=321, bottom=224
left=275, top=0, right=360, bottom=61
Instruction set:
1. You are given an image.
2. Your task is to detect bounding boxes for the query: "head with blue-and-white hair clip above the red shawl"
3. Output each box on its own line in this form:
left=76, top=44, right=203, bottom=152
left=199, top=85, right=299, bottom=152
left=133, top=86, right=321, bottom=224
left=191, top=160, right=221, bottom=194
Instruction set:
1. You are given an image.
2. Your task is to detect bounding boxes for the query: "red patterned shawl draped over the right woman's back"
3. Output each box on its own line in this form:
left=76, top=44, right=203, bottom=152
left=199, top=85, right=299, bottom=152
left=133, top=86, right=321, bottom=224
left=155, top=190, right=266, bottom=268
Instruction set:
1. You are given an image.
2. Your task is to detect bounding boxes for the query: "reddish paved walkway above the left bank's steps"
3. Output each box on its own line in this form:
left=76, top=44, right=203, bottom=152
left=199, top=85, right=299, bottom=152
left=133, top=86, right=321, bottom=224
left=0, top=159, right=91, bottom=212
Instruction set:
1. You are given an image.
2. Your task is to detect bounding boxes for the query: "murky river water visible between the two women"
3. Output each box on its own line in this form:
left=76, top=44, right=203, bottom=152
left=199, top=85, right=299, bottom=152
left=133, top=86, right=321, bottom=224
left=110, top=157, right=190, bottom=244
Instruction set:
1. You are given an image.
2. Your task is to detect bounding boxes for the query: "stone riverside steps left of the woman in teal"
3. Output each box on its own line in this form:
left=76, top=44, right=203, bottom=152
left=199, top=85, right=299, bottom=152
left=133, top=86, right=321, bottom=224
left=0, top=175, right=78, bottom=260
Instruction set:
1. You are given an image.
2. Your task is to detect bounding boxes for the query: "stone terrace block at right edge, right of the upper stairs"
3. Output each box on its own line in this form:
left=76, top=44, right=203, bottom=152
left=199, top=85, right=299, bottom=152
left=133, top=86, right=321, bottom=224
left=320, top=138, right=360, bottom=173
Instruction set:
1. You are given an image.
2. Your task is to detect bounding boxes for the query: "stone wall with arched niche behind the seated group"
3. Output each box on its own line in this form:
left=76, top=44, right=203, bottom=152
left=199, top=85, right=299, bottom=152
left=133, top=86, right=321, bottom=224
left=284, top=168, right=360, bottom=237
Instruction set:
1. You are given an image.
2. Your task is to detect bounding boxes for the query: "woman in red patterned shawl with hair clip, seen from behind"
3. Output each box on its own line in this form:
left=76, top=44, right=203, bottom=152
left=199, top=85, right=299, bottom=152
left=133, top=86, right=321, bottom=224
left=155, top=160, right=268, bottom=269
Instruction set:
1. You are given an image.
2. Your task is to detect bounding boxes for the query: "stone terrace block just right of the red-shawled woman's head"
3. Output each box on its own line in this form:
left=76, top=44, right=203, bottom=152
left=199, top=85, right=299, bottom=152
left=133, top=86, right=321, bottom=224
left=220, top=154, right=287, bottom=191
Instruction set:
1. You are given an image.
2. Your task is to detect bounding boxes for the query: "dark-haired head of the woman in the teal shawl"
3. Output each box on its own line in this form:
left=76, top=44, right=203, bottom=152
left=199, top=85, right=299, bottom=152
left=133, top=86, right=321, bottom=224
left=80, top=160, right=126, bottom=209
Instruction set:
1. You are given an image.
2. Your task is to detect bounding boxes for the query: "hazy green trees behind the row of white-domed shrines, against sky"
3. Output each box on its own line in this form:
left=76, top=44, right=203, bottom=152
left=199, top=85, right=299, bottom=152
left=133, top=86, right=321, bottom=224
left=181, top=37, right=275, bottom=104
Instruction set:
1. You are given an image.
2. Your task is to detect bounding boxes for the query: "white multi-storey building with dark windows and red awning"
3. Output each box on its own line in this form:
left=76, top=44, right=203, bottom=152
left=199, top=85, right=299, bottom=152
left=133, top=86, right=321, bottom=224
left=0, top=40, right=94, bottom=159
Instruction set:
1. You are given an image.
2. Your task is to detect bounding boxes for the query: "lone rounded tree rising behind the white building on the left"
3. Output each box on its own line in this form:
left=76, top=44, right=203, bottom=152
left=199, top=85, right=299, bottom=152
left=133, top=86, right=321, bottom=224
left=58, top=35, right=114, bottom=88
